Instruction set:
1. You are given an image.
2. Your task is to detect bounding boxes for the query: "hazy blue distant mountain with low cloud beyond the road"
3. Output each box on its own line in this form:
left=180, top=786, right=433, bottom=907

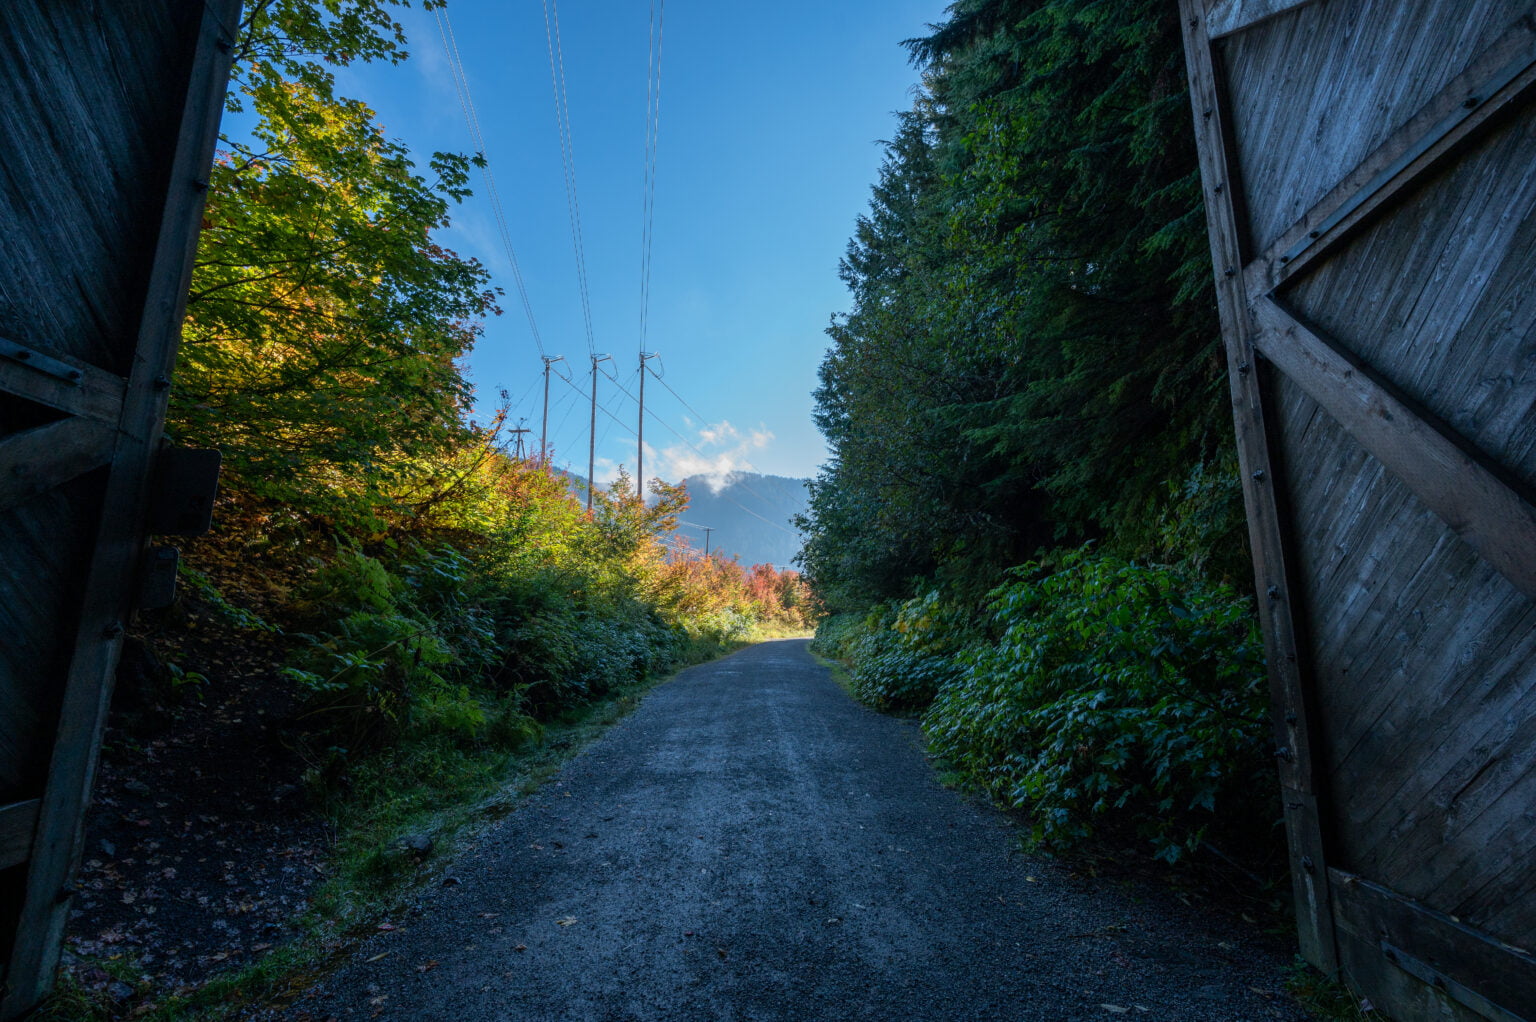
left=677, top=472, right=808, bottom=567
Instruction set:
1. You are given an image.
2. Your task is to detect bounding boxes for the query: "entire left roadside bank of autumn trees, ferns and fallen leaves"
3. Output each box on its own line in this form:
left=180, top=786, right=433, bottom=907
left=41, top=0, right=816, bottom=1019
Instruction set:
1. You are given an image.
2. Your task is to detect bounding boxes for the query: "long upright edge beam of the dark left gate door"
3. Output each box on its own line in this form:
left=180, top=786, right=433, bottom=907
left=0, top=0, right=241, bottom=1017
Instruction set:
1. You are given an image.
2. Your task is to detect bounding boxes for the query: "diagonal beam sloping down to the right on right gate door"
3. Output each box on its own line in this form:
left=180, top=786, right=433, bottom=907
left=1253, top=298, right=1536, bottom=598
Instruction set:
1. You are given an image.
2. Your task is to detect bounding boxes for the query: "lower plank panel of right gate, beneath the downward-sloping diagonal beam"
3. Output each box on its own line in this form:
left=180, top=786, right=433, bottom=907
left=1276, top=374, right=1536, bottom=942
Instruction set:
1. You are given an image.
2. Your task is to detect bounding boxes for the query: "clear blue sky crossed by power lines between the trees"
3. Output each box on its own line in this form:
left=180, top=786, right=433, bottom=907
left=338, top=0, right=943, bottom=479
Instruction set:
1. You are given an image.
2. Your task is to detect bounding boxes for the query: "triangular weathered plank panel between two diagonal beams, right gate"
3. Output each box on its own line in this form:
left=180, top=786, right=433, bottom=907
left=1284, top=109, right=1536, bottom=489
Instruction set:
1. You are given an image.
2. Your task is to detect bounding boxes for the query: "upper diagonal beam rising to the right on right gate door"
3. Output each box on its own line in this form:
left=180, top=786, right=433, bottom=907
left=1243, top=18, right=1536, bottom=300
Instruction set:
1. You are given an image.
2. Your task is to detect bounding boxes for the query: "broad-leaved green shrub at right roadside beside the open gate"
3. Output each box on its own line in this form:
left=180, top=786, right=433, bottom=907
left=925, top=550, right=1272, bottom=862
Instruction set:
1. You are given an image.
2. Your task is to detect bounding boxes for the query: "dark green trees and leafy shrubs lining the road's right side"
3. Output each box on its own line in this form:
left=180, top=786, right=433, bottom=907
left=800, top=0, right=1279, bottom=881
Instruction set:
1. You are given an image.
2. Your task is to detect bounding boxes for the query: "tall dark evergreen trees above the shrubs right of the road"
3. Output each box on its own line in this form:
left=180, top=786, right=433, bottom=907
left=802, top=0, right=1241, bottom=609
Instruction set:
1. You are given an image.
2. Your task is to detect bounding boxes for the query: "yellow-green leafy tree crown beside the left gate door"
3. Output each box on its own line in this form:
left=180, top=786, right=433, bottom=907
left=170, top=0, right=496, bottom=523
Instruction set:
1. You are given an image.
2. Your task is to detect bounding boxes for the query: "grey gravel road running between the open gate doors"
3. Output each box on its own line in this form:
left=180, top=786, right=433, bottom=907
left=270, top=641, right=1306, bottom=1022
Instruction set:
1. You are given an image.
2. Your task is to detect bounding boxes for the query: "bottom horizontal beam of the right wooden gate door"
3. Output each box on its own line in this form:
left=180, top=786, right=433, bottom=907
left=1329, top=870, right=1536, bottom=1020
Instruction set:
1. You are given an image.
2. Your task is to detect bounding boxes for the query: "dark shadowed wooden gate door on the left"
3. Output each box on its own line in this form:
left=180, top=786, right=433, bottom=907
left=0, top=0, right=240, bottom=1019
